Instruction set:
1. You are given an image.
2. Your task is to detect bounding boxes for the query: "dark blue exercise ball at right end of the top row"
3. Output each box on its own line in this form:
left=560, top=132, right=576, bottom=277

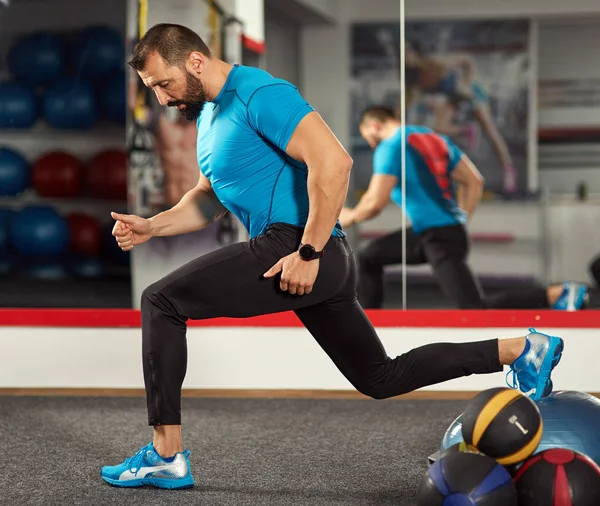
left=72, top=26, right=125, bottom=79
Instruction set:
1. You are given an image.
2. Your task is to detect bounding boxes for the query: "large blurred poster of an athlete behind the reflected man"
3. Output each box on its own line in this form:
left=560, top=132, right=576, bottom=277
left=352, top=20, right=533, bottom=196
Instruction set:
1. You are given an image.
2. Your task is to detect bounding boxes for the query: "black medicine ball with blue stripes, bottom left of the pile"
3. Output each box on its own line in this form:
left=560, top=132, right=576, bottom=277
left=417, top=452, right=518, bottom=506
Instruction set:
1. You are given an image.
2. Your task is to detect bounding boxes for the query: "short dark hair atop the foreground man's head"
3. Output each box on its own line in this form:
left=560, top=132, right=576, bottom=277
left=129, top=23, right=211, bottom=71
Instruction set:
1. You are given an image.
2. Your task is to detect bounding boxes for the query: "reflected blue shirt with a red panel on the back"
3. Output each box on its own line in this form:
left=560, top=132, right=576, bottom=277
left=373, top=125, right=467, bottom=234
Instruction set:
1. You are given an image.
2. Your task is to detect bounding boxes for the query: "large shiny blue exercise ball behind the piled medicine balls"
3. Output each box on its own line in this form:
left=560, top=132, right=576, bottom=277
left=440, top=390, right=600, bottom=465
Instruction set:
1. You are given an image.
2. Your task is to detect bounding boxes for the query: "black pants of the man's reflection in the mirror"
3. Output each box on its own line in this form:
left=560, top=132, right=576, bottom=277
left=358, top=225, right=549, bottom=309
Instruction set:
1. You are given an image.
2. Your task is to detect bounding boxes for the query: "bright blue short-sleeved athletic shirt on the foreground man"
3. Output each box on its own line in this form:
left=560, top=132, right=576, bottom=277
left=196, top=65, right=345, bottom=237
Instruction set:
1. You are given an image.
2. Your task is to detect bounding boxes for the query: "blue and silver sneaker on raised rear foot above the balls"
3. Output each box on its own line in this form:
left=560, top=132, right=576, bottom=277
left=506, top=328, right=564, bottom=401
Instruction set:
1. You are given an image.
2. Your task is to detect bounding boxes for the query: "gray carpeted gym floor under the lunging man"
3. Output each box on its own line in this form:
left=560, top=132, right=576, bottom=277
left=0, top=397, right=466, bottom=506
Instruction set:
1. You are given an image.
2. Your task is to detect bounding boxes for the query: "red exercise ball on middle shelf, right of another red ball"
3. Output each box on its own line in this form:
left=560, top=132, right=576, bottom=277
left=87, top=149, right=127, bottom=200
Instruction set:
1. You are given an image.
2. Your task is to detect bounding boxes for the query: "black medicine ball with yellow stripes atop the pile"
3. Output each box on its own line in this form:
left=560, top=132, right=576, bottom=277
left=462, top=387, right=543, bottom=466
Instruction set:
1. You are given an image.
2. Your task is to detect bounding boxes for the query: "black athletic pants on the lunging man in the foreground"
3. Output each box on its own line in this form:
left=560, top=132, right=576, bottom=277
left=142, top=224, right=502, bottom=425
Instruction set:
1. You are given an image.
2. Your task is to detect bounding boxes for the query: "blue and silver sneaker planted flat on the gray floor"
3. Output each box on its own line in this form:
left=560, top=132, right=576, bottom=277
left=100, top=443, right=194, bottom=489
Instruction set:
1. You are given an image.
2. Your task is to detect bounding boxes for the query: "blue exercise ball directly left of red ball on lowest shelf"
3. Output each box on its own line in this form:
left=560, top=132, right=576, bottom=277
left=9, top=205, right=69, bottom=258
